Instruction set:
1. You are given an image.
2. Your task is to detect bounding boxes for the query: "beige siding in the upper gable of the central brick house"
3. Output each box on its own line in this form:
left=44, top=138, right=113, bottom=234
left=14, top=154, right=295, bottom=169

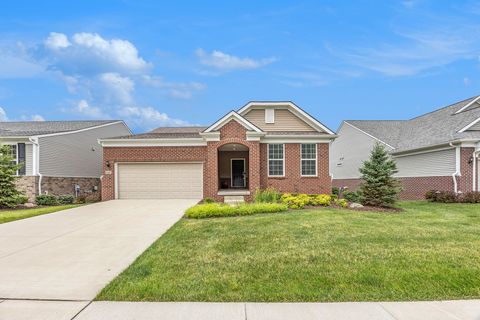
left=244, top=109, right=316, bottom=131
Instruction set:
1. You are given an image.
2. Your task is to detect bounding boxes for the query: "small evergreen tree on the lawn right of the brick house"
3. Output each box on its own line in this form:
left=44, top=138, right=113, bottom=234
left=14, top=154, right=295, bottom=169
left=360, top=143, right=402, bottom=207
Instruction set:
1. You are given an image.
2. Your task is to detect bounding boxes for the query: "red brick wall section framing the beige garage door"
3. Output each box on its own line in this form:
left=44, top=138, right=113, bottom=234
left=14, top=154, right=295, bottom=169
left=102, top=147, right=207, bottom=200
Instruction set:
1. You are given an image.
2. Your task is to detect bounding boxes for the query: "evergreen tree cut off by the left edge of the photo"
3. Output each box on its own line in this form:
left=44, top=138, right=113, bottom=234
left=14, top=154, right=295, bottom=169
left=0, top=145, right=24, bottom=208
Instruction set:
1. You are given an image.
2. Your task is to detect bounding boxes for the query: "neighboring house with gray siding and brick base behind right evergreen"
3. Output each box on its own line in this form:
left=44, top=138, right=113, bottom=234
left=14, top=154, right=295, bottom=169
left=330, top=96, right=480, bottom=199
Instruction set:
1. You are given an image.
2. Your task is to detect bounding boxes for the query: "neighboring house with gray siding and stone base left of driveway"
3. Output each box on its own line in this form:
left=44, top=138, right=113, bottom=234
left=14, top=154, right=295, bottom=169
left=0, top=120, right=131, bottom=201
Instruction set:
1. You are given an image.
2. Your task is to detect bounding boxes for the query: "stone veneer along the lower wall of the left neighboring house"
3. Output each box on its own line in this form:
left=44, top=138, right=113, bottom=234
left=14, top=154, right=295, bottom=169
left=42, top=176, right=101, bottom=201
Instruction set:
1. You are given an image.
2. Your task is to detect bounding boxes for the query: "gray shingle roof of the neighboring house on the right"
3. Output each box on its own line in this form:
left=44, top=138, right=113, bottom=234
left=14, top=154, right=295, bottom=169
left=346, top=97, right=480, bottom=152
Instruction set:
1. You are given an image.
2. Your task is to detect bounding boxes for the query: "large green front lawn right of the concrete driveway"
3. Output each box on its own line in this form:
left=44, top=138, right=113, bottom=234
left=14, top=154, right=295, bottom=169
left=97, top=202, right=480, bottom=302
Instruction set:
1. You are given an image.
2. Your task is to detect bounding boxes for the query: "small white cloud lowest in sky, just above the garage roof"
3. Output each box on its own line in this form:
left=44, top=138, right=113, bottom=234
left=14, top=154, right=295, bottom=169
left=118, top=107, right=190, bottom=129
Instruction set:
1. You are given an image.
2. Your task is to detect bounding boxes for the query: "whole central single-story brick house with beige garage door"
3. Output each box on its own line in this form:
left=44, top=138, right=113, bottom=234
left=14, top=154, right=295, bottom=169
left=100, top=102, right=335, bottom=201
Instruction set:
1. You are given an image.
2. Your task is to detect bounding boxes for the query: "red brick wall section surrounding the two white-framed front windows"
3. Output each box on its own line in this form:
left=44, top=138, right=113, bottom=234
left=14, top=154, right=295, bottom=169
left=260, top=143, right=332, bottom=194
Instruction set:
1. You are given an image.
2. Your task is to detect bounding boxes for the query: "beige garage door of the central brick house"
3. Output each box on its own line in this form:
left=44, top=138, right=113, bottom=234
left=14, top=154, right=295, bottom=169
left=117, top=163, right=203, bottom=199
